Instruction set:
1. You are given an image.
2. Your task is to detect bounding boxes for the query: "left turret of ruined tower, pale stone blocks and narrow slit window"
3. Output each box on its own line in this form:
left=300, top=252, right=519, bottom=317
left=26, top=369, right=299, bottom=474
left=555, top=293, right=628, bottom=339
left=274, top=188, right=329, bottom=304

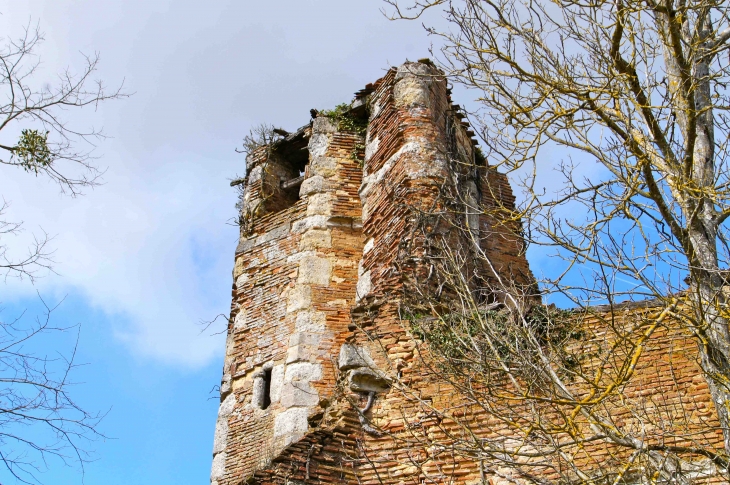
left=211, top=117, right=370, bottom=484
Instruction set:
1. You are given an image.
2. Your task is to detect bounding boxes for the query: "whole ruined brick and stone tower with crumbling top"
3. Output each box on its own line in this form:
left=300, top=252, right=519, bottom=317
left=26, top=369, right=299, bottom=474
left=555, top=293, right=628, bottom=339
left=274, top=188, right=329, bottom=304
left=211, top=61, right=531, bottom=485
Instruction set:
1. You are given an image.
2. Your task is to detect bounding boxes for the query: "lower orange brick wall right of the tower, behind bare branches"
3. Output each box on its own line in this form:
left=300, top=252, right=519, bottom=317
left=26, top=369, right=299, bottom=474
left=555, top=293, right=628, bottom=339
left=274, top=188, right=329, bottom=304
left=346, top=306, right=727, bottom=485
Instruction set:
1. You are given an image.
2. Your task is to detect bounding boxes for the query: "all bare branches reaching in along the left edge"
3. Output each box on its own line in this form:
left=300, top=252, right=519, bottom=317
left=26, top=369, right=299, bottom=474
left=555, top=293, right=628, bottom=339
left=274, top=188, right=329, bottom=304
left=0, top=18, right=128, bottom=483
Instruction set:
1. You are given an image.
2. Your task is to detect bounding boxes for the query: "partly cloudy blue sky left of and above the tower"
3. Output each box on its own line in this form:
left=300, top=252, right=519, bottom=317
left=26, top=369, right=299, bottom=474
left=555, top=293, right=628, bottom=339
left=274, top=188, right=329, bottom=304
left=0, top=0, right=430, bottom=485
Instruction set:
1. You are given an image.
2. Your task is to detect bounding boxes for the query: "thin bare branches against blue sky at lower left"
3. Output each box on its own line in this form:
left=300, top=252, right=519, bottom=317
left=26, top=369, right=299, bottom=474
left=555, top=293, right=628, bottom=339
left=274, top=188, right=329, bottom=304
left=0, top=299, right=104, bottom=483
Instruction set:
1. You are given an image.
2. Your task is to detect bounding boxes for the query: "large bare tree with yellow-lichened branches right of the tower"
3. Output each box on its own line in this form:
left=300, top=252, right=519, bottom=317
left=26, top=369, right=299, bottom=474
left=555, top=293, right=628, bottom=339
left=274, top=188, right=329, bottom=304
left=376, top=0, right=730, bottom=483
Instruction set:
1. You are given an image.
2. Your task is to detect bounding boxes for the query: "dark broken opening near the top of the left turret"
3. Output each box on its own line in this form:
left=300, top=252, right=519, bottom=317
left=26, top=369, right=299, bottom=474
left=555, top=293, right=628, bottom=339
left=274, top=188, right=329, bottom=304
left=262, top=129, right=309, bottom=212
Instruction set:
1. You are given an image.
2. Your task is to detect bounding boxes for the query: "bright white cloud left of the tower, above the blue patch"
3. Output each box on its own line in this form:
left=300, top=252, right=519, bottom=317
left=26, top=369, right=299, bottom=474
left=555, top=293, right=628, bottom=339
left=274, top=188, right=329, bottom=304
left=4, top=145, right=237, bottom=365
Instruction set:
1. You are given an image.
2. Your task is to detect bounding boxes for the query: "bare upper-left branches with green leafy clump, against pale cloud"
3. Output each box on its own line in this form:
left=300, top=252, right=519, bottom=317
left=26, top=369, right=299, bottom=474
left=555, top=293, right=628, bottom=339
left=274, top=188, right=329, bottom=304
left=0, top=22, right=128, bottom=281
